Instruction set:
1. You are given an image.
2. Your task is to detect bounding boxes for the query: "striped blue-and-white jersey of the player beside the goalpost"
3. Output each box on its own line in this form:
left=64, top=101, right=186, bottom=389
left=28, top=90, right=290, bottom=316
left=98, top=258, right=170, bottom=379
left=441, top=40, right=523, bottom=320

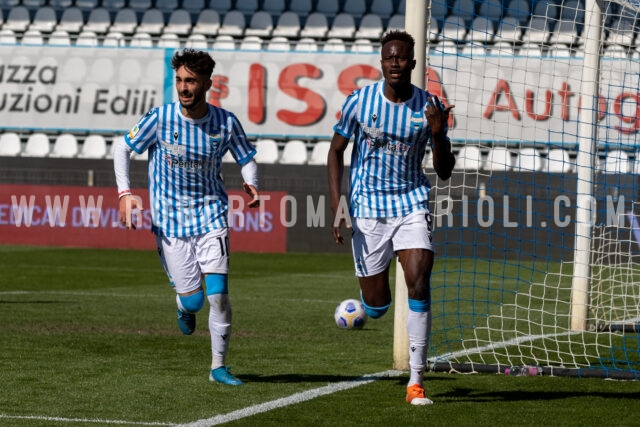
left=333, top=81, right=448, bottom=218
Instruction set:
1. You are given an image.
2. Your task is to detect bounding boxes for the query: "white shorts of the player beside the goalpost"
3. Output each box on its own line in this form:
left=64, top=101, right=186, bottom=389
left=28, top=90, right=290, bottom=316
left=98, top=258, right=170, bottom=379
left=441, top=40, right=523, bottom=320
left=351, top=210, right=433, bottom=277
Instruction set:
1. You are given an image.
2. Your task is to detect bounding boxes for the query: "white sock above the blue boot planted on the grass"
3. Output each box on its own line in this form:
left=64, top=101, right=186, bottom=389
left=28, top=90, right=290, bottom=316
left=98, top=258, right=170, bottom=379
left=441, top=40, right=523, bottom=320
left=207, top=294, right=231, bottom=369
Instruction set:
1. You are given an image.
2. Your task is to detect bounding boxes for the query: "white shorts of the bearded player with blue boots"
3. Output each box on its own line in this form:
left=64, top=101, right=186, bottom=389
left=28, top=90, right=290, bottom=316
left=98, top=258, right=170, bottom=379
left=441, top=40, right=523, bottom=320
left=156, top=228, right=229, bottom=294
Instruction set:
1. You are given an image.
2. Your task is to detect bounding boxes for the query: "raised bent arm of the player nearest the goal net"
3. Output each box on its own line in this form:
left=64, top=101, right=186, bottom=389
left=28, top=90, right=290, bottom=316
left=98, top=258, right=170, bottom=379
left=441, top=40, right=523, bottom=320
left=424, top=96, right=456, bottom=181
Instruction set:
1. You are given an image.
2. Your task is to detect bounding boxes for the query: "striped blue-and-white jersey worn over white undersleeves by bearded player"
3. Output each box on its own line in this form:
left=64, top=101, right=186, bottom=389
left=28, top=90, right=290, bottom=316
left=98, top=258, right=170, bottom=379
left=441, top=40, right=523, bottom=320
left=125, top=102, right=256, bottom=237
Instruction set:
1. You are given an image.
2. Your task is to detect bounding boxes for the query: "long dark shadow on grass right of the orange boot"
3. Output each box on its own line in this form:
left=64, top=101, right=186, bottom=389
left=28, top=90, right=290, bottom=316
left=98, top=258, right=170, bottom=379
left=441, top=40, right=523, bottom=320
left=438, top=388, right=640, bottom=402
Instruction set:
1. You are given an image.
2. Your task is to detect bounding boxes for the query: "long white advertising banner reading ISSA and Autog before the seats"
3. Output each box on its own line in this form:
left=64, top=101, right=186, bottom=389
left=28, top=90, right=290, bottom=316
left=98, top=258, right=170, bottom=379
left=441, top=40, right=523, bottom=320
left=0, top=46, right=640, bottom=146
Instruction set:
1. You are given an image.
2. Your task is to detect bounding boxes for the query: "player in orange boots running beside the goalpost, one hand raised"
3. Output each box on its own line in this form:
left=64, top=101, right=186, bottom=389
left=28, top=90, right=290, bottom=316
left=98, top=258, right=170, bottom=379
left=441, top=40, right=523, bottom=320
left=327, top=31, right=455, bottom=405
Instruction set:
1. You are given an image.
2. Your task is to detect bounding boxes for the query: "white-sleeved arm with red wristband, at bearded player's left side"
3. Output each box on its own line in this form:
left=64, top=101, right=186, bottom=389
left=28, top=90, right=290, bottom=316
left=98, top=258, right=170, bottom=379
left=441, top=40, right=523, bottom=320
left=113, top=138, right=142, bottom=228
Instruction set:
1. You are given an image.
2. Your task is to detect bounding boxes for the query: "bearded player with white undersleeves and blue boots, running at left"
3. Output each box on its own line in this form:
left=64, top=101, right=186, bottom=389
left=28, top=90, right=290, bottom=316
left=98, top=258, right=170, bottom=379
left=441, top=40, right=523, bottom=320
left=113, top=49, right=260, bottom=385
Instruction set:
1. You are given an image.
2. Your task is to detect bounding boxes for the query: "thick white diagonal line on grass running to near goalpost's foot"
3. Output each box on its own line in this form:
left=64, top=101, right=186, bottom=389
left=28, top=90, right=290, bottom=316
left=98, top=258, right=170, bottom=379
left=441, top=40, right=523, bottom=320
left=179, top=370, right=403, bottom=427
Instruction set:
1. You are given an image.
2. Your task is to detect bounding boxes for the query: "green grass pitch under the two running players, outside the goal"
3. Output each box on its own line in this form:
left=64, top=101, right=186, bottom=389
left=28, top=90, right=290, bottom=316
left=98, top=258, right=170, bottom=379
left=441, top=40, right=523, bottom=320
left=0, top=246, right=640, bottom=427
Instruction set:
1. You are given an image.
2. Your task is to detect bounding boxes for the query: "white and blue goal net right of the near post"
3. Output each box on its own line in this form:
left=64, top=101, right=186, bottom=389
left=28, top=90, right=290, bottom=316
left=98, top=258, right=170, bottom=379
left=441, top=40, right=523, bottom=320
left=425, top=0, right=640, bottom=378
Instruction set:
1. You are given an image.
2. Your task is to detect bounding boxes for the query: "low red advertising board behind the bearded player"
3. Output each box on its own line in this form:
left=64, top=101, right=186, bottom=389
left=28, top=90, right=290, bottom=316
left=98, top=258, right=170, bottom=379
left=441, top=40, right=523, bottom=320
left=0, top=185, right=287, bottom=252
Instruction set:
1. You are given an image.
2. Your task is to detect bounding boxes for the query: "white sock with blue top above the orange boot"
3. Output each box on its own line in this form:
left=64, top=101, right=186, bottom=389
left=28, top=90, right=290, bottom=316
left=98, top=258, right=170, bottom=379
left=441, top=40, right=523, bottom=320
left=407, top=299, right=431, bottom=385
